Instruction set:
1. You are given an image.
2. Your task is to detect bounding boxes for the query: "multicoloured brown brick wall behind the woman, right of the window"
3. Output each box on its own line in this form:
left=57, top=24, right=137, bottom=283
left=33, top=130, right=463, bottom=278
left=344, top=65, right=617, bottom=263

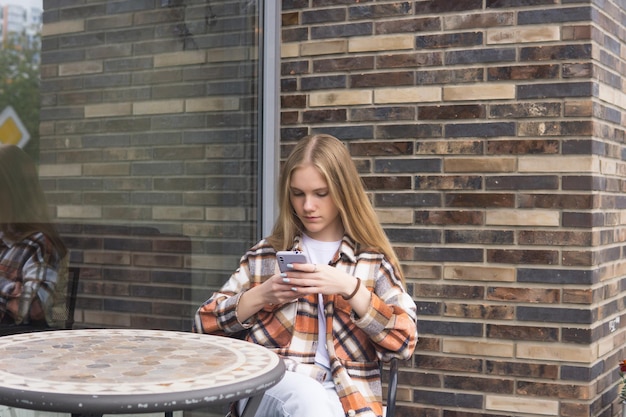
left=281, top=0, right=626, bottom=417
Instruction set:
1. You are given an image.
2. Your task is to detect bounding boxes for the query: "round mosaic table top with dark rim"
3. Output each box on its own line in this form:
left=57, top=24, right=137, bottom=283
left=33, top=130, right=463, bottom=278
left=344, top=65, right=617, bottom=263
left=0, top=329, right=284, bottom=413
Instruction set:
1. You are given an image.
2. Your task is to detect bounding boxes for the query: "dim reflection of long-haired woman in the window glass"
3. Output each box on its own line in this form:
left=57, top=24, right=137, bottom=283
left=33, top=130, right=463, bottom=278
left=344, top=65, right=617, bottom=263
left=0, top=145, right=67, bottom=327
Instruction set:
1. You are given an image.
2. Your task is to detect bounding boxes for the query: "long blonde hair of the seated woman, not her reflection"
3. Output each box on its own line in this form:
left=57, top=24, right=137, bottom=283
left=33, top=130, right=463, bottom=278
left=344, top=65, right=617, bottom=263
left=268, top=134, right=404, bottom=282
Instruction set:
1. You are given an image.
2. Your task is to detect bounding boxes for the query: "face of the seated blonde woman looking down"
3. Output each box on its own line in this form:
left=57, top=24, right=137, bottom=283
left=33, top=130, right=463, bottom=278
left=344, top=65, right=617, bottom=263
left=289, top=165, right=344, bottom=242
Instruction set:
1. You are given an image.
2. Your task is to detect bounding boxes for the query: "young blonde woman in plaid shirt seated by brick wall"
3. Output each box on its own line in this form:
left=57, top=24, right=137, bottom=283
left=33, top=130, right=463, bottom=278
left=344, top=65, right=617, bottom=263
left=194, top=135, right=417, bottom=417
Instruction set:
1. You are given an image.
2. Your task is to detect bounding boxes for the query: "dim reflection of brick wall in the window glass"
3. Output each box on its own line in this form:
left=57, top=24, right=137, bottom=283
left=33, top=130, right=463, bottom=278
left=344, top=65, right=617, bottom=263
left=18, top=0, right=278, bottom=330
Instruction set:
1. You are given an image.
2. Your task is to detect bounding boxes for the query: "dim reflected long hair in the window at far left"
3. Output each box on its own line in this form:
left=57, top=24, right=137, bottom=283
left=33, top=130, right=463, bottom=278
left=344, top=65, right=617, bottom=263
left=0, top=145, right=67, bottom=258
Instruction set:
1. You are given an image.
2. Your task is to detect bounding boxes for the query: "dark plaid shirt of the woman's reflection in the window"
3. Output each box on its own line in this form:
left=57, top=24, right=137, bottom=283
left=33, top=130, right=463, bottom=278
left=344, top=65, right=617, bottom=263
left=0, top=232, right=60, bottom=324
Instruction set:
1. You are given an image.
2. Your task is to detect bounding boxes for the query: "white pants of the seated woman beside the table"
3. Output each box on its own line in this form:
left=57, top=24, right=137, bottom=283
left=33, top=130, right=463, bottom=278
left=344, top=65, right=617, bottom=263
left=237, top=371, right=346, bottom=417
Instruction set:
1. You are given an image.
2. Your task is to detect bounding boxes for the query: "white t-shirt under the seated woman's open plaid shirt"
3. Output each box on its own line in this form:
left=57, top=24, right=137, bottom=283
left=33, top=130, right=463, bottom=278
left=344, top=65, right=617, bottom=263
left=302, top=235, right=341, bottom=368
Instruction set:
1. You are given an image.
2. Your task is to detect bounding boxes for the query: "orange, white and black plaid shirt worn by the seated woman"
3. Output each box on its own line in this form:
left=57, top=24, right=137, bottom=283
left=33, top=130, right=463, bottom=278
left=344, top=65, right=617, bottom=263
left=194, top=236, right=417, bottom=417
